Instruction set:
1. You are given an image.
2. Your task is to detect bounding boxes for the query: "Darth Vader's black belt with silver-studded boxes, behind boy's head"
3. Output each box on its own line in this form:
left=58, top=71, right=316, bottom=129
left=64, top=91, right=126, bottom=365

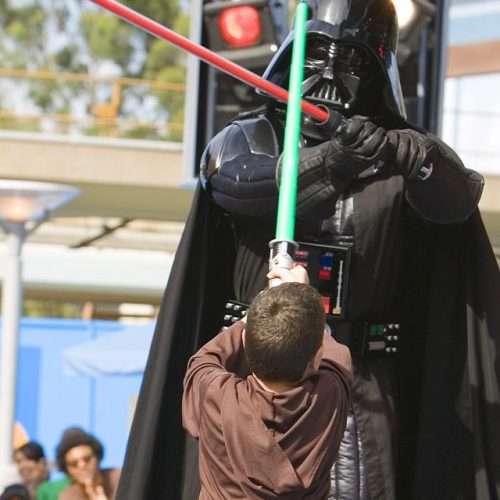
left=223, top=301, right=400, bottom=356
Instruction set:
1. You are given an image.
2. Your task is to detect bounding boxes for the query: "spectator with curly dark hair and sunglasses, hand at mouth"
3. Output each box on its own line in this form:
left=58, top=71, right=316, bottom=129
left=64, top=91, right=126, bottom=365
left=56, top=429, right=120, bottom=500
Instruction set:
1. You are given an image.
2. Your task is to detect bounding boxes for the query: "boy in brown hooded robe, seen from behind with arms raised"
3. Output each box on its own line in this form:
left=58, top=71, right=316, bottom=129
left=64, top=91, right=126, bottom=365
left=182, top=266, right=351, bottom=500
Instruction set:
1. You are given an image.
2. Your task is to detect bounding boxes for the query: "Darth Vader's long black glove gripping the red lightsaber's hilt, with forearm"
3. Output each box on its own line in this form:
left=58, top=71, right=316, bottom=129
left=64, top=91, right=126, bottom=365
left=277, top=116, right=387, bottom=219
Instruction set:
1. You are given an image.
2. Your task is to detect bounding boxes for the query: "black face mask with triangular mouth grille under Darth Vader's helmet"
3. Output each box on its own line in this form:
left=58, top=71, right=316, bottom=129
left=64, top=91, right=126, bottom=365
left=302, top=37, right=378, bottom=111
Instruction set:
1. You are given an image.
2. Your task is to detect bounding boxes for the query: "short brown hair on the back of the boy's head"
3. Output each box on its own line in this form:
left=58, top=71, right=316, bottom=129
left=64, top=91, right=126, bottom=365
left=245, top=283, right=325, bottom=382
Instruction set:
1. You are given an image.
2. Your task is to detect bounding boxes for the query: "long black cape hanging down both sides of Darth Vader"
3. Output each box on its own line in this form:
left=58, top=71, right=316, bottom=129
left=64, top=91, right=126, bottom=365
left=117, top=187, right=500, bottom=500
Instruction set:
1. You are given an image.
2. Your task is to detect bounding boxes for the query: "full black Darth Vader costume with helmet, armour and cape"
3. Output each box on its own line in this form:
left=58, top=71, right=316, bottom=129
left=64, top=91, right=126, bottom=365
left=118, top=0, right=500, bottom=500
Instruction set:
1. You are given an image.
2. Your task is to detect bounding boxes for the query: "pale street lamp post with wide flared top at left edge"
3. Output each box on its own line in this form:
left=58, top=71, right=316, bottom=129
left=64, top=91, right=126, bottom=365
left=0, top=180, right=78, bottom=486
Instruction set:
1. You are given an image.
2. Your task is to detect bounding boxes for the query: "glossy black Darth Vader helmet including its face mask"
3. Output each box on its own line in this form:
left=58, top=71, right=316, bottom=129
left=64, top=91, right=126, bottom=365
left=263, top=0, right=405, bottom=118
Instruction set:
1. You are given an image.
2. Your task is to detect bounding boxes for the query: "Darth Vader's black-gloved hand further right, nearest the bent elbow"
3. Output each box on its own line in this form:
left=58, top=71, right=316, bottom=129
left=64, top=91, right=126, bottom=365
left=387, top=129, right=438, bottom=180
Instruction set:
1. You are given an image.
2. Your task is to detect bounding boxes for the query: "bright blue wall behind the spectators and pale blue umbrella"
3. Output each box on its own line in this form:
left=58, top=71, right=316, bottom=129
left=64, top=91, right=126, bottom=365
left=4, top=318, right=154, bottom=467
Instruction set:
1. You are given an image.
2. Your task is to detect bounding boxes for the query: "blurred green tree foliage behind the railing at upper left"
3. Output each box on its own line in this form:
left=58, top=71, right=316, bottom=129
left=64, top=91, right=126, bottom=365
left=0, top=0, right=189, bottom=138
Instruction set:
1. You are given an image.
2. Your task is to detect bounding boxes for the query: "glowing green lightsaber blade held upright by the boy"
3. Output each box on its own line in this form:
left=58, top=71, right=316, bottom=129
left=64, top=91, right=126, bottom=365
left=276, top=2, right=308, bottom=240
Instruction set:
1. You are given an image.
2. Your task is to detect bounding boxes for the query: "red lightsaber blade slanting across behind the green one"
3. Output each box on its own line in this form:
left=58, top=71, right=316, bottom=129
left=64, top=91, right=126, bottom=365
left=90, top=0, right=329, bottom=122
